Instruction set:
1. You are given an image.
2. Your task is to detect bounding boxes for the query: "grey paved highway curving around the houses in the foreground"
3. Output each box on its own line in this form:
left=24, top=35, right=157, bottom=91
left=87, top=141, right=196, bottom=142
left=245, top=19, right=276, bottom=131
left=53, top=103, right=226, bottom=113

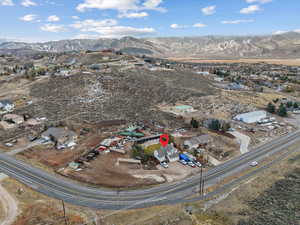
left=0, top=131, right=300, bottom=210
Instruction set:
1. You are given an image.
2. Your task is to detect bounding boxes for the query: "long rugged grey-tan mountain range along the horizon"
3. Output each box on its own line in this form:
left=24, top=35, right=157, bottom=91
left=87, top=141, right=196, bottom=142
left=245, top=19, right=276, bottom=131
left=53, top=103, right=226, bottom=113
left=0, top=32, right=300, bottom=59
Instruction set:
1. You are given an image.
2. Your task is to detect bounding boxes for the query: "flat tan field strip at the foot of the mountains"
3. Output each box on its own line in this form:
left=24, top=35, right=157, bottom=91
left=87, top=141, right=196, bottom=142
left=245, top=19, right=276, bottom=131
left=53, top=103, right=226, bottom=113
left=170, top=58, right=300, bottom=66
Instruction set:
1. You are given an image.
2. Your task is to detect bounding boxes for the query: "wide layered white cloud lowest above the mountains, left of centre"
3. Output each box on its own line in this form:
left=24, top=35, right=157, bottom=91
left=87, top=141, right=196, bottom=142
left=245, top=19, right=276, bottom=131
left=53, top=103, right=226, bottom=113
left=70, top=19, right=155, bottom=38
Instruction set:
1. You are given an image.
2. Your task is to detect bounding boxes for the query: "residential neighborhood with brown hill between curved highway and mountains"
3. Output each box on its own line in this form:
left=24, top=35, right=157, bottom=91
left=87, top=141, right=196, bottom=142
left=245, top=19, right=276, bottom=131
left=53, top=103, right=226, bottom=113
left=0, top=49, right=300, bottom=190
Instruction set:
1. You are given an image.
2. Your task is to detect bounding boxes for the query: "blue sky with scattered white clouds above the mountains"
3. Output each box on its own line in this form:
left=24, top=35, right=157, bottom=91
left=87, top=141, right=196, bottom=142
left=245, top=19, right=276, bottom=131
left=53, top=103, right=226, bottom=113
left=0, top=0, right=300, bottom=41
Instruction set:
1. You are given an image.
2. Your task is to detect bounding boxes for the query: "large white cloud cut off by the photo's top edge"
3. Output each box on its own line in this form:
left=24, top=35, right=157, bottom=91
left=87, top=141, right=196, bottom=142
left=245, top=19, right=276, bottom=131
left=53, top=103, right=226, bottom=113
left=76, top=0, right=165, bottom=12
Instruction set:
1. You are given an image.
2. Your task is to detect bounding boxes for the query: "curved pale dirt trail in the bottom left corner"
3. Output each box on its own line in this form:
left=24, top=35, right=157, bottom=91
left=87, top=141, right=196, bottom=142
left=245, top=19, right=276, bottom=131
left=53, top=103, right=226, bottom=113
left=0, top=185, right=18, bottom=225
